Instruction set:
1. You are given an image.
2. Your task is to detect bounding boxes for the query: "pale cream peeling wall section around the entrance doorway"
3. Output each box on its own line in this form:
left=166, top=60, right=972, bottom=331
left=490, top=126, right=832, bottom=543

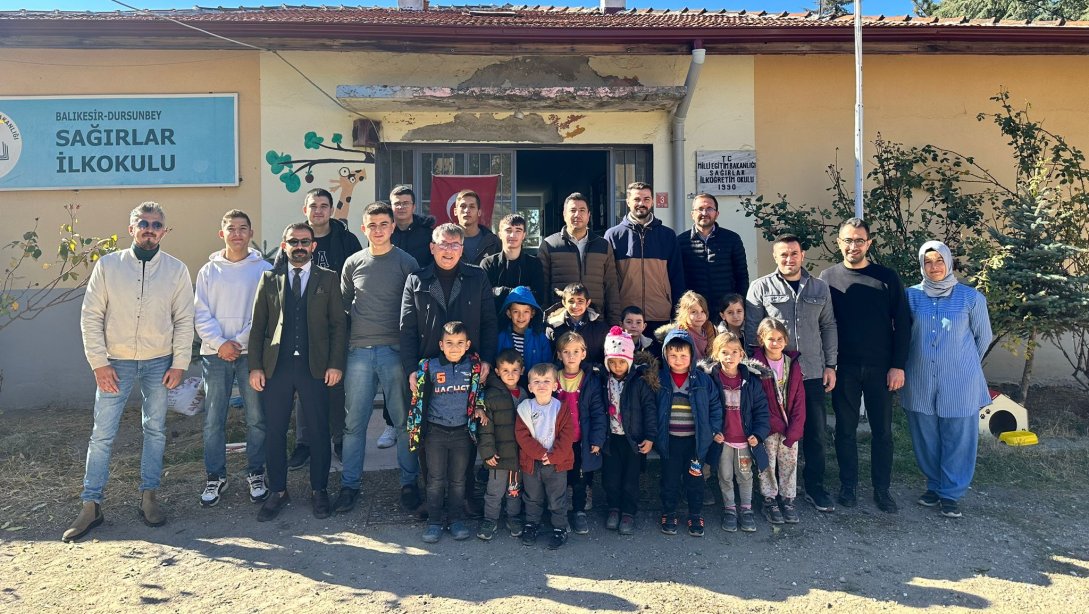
left=261, top=52, right=756, bottom=266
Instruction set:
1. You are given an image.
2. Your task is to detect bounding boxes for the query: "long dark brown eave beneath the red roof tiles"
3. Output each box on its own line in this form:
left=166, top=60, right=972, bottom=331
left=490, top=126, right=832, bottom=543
left=0, top=20, right=1089, bottom=53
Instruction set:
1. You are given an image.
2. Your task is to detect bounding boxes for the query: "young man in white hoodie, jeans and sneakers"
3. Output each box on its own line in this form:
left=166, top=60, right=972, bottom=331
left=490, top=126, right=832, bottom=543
left=194, top=209, right=272, bottom=507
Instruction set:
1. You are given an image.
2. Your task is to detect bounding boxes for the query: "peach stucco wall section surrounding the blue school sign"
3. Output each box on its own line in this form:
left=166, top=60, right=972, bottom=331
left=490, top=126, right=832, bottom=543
left=0, top=49, right=260, bottom=275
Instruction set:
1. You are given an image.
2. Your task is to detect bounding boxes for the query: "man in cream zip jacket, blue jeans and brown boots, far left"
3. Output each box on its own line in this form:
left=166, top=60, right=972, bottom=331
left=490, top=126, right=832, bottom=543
left=62, top=202, right=193, bottom=541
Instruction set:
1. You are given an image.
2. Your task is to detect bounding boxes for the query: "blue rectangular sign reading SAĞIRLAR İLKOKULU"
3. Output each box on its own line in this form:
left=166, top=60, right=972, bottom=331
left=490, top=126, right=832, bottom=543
left=0, top=94, right=238, bottom=189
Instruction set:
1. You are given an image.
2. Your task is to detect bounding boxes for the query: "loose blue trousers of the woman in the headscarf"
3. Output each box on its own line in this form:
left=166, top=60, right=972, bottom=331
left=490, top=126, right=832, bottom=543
left=905, top=412, right=979, bottom=501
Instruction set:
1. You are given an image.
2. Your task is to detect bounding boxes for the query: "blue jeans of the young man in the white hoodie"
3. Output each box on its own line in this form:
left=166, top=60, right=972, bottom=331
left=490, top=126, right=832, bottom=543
left=200, top=354, right=265, bottom=478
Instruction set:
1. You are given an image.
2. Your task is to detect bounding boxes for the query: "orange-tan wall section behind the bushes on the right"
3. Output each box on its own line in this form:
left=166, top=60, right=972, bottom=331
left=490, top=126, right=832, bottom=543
left=755, top=56, right=1089, bottom=382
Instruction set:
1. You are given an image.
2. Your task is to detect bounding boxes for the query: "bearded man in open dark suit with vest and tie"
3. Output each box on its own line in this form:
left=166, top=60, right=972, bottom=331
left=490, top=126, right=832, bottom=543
left=249, top=222, right=347, bottom=521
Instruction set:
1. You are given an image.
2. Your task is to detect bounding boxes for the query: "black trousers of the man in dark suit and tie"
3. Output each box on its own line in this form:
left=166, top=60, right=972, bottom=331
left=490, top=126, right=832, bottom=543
left=260, top=356, right=330, bottom=492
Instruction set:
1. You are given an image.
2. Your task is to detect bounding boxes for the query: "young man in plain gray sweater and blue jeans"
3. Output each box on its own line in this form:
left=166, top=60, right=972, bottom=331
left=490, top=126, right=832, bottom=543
left=333, top=202, right=419, bottom=513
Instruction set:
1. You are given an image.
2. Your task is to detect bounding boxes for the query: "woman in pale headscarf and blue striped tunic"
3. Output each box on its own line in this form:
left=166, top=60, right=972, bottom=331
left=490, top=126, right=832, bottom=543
left=901, top=241, right=991, bottom=518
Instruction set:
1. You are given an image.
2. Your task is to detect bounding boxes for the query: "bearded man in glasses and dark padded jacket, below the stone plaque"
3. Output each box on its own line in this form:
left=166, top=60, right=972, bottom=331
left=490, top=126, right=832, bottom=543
left=677, top=194, right=748, bottom=323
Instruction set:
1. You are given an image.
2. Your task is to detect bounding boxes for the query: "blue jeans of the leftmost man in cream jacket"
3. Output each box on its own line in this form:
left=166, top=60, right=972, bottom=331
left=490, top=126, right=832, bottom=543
left=79, top=356, right=173, bottom=503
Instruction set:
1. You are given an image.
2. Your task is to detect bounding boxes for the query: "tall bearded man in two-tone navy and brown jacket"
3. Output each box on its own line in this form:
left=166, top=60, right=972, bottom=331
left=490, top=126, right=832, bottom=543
left=605, top=182, right=685, bottom=330
